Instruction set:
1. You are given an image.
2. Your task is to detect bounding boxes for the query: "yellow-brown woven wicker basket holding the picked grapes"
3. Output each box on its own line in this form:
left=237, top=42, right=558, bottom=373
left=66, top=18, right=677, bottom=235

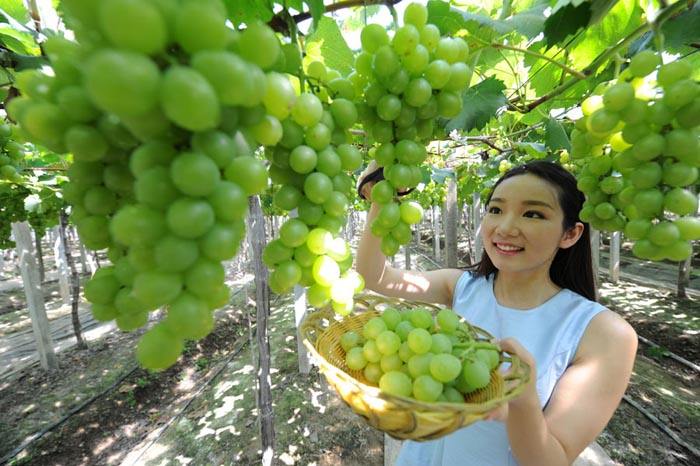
left=300, top=294, right=530, bottom=441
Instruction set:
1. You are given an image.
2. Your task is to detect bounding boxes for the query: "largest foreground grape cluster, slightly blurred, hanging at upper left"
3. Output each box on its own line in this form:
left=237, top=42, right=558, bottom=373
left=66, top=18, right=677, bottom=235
left=8, top=0, right=289, bottom=369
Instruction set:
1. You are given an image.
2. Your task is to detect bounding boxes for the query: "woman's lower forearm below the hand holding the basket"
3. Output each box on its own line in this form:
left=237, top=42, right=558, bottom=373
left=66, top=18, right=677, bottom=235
left=506, top=394, right=570, bottom=466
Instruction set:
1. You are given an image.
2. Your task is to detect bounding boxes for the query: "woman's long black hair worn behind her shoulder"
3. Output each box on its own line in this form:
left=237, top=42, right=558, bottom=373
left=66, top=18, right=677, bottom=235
left=469, top=160, right=596, bottom=301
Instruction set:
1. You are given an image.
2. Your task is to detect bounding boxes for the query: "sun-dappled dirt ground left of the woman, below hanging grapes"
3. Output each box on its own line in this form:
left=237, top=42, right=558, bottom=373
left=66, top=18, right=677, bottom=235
left=0, top=274, right=383, bottom=465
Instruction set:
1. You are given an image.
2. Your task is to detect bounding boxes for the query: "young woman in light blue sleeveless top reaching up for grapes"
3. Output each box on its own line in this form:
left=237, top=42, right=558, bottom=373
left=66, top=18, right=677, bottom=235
left=357, top=161, right=637, bottom=466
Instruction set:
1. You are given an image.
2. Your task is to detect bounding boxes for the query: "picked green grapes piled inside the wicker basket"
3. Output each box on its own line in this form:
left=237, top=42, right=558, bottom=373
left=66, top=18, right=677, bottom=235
left=340, top=308, right=500, bottom=403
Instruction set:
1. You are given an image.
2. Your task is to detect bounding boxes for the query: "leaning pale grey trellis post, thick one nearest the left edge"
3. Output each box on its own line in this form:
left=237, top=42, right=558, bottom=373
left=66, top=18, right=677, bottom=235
left=12, top=222, right=58, bottom=370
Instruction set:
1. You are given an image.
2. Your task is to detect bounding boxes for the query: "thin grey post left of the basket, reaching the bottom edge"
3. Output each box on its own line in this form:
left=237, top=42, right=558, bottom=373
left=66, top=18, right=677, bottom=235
left=248, top=196, right=275, bottom=466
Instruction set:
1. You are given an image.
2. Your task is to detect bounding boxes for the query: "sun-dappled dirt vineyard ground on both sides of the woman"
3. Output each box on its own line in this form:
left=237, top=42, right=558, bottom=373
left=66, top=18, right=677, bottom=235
left=0, top=237, right=700, bottom=466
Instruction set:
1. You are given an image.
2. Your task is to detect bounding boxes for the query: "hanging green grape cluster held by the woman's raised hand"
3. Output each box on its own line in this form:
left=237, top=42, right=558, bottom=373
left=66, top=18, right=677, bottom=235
left=354, top=3, right=471, bottom=256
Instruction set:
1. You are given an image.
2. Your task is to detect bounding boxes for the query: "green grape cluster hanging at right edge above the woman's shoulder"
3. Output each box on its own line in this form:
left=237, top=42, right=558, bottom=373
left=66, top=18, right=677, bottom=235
left=571, top=51, right=700, bottom=261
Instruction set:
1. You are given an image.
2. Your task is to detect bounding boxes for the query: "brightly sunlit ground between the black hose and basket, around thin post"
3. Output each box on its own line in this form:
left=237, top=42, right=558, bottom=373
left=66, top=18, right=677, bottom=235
left=123, top=290, right=383, bottom=465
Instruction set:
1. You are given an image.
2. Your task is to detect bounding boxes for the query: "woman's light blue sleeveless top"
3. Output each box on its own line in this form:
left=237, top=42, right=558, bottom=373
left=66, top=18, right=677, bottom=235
left=396, top=272, right=605, bottom=466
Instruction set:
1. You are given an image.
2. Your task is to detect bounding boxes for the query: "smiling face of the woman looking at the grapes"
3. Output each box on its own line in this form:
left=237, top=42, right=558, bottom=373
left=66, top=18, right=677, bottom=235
left=481, top=174, right=583, bottom=273
